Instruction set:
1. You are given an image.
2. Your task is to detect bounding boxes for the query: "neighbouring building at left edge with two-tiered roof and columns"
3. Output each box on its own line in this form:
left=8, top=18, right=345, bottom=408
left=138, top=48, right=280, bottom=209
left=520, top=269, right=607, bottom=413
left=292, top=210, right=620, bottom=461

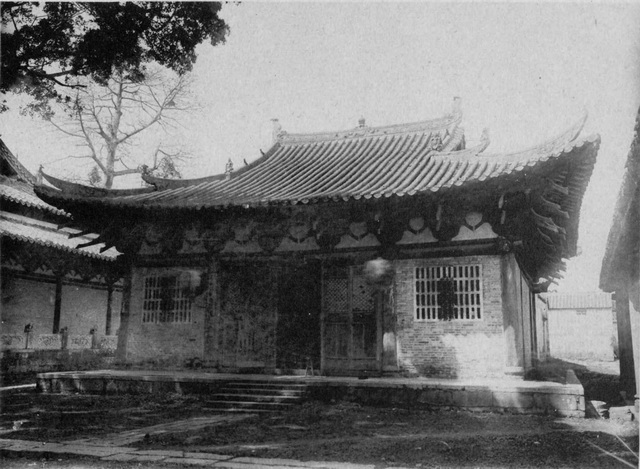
left=0, top=140, right=122, bottom=350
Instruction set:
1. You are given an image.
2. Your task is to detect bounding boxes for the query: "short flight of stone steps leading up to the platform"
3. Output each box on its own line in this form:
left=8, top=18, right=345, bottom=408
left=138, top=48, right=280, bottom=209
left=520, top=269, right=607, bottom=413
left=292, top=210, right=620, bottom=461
left=206, top=380, right=307, bottom=412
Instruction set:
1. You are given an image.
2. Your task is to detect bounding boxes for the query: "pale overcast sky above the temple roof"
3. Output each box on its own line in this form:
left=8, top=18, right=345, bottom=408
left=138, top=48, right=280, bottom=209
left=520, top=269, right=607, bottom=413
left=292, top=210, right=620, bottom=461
left=0, top=2, right=640, bottom=290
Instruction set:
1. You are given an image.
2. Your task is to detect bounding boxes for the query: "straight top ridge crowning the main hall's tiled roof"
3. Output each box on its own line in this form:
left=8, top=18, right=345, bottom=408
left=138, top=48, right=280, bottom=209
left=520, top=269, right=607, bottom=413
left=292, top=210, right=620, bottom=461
left=277, top=109, right=462, bottom=145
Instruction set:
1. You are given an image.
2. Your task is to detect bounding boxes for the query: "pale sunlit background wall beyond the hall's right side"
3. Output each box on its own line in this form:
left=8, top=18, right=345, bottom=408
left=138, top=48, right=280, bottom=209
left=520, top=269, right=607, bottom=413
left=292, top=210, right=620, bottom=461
left=549, top=308, right=617, bottom=361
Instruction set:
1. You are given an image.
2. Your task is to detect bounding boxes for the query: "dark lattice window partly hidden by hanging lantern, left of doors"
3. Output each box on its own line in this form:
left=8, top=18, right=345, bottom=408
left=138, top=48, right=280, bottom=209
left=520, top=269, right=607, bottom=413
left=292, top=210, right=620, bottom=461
left=142, top=274, right=191, bottom=323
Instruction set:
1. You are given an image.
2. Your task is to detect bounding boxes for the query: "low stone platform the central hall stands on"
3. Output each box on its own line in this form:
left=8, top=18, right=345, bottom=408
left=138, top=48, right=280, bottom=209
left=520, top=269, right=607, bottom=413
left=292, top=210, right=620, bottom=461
left=38, top=370, right=585, bottom=417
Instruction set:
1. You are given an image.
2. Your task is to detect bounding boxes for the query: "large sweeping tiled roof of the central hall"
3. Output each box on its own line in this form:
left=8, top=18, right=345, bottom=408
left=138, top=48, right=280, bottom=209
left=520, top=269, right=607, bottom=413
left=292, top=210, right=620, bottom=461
left=36, top=108, right=599, bottom=209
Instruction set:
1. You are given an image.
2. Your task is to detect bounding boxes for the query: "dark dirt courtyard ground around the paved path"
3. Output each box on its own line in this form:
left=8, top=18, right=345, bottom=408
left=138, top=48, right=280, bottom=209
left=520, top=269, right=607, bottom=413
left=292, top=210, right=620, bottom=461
left=0, top=358, right=638, bottom=469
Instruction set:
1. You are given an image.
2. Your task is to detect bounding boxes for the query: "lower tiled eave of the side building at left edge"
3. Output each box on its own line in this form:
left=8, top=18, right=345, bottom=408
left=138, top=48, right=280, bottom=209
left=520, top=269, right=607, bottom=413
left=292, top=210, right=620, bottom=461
left=0, top=211, right=119, bottom=260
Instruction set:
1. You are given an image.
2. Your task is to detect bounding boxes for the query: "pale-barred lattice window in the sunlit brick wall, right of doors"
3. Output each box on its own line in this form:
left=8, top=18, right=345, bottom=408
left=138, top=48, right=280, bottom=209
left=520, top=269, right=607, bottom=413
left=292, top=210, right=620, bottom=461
left=414, top=264, right=482, bottom=321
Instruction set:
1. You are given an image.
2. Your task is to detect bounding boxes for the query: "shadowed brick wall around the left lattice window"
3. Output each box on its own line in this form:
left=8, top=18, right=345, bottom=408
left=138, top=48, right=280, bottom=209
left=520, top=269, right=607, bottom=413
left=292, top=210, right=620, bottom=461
left=126, top=267, right=207, bottom=367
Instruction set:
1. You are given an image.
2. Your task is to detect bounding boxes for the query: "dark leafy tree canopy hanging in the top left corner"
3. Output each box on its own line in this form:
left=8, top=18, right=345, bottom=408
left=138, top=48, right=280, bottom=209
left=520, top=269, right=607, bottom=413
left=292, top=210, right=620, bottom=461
left=0, top=2, right=229, bottom=110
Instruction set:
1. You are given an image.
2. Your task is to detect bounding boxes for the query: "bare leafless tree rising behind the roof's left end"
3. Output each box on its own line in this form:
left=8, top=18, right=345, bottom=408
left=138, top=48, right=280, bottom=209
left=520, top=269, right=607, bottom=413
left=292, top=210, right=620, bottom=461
left=43, top=64, right=197, bottom=187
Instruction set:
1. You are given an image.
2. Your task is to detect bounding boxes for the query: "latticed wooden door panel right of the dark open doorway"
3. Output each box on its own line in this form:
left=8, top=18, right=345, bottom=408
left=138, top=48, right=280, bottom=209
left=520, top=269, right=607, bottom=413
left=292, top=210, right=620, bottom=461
left=322, top=266, right=379, bottom=374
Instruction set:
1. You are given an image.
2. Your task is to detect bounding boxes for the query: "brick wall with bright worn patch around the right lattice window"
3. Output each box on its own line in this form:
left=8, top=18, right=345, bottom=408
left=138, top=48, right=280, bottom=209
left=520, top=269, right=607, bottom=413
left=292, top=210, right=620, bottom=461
left=394, top=256, right=505, bottom=378
